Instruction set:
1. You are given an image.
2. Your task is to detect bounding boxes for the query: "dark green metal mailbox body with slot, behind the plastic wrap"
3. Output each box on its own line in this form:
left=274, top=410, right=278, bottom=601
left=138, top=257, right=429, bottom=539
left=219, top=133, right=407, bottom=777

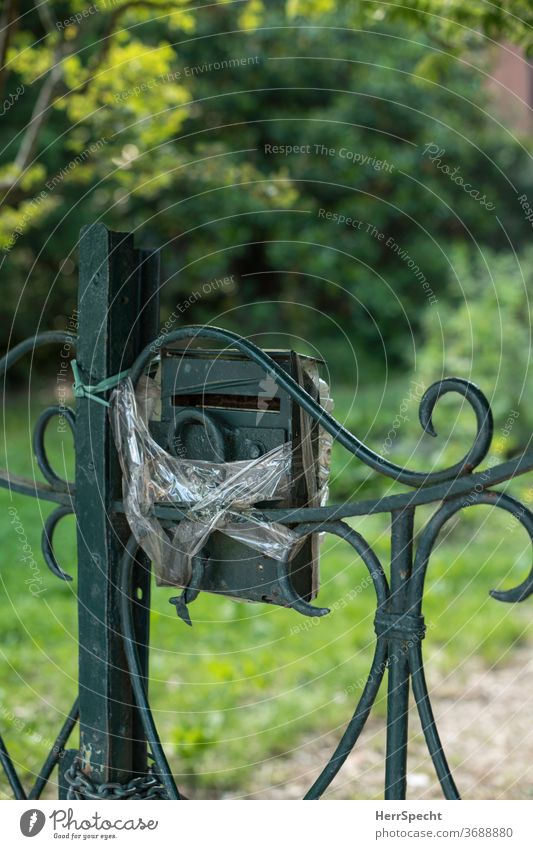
left=151, top=348, right=319, bottom=605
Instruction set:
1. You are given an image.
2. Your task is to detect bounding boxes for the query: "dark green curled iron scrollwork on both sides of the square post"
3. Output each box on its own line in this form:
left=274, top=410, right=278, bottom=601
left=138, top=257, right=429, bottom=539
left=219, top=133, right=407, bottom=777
left=0, top=326, right=533, bottom=799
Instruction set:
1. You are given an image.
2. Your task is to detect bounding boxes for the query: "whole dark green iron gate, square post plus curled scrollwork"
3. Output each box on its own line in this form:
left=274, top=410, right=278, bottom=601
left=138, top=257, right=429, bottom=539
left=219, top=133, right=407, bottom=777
left=0, top=224, right=533, bottom=799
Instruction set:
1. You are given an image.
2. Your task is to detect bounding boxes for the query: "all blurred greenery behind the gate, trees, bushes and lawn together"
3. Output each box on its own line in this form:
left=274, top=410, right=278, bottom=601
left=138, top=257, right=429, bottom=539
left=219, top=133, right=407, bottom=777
left=0, top=0, right=533, bottom=794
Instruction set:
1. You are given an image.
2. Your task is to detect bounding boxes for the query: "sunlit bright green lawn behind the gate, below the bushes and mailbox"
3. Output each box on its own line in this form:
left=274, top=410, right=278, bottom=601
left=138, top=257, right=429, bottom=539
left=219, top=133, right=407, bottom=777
left=0, top=382, right=531, bottom=798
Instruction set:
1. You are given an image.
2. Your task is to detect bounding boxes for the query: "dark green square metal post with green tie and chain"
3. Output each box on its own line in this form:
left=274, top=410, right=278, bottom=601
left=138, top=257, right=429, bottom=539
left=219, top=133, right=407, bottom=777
left=76, top=224, right=159, bottom=784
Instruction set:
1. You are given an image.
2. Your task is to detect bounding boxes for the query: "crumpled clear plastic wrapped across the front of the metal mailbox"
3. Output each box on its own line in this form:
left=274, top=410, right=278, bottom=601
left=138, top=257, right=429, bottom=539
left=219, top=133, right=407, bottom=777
left=110, top=377, right=301, bottom=587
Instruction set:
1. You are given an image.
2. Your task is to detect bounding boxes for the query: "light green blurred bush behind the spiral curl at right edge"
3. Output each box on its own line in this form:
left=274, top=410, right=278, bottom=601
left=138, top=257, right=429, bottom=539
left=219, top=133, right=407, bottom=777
left=418, top=248, right=533, bottom=461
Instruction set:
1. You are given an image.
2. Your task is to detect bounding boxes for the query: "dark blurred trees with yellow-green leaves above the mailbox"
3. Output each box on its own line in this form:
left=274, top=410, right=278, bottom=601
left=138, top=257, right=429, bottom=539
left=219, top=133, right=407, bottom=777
left=0, top=0, right=533, bottom=378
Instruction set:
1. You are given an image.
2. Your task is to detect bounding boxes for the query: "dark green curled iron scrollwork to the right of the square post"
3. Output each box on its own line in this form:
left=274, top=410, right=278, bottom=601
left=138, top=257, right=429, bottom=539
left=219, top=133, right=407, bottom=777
left=116, top=327, right=533, bottom=799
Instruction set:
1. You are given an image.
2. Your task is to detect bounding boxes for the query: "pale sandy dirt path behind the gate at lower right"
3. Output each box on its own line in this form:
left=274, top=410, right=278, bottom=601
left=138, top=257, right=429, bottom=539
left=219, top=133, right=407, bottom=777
left=248, top=646, right=533, bottom=799
